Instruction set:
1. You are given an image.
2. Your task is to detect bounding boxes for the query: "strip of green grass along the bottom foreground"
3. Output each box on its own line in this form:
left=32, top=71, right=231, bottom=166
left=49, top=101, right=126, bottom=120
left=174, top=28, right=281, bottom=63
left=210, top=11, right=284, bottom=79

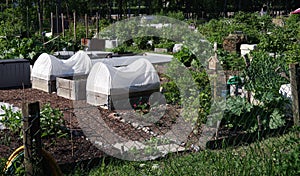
left=71, top=131, right=300, bottom=176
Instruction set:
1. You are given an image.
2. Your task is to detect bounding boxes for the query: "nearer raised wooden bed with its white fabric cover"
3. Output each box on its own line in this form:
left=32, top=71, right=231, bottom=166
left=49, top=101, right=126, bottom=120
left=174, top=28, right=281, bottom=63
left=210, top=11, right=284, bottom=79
left=86, top=59, right=160, bottom=109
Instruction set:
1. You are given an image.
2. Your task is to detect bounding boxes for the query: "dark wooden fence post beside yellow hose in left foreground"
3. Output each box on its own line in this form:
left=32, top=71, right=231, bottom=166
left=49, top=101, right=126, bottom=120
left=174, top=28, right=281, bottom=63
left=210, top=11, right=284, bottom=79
left=22, top=102, right=43, bottom=176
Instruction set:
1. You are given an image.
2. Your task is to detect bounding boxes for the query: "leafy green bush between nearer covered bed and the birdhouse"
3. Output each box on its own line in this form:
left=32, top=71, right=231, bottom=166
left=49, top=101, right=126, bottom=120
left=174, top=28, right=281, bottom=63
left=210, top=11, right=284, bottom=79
left=162, top=48, right=211, bottom=125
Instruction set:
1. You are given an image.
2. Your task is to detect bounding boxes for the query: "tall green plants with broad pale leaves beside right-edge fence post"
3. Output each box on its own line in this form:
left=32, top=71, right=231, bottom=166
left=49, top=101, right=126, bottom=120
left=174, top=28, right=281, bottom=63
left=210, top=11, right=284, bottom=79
left=225, top=51, right=289, bottom=132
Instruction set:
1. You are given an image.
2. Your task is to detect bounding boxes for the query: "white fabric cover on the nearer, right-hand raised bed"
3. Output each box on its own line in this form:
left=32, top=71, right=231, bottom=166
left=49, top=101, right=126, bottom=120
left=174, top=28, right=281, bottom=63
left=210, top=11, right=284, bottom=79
left=86, top=58, right=159, bottom=95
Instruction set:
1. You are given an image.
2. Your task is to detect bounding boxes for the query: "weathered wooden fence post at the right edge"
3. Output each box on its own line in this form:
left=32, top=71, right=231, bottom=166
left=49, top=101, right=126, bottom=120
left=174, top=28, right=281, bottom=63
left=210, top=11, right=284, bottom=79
left=289, top=63, right=300, bottom=126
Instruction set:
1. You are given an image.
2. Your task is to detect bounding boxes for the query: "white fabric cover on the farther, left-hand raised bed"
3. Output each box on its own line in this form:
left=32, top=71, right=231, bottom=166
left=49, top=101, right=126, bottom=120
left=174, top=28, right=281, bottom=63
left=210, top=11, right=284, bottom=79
left=31, top=51, right=92, bottom=80
